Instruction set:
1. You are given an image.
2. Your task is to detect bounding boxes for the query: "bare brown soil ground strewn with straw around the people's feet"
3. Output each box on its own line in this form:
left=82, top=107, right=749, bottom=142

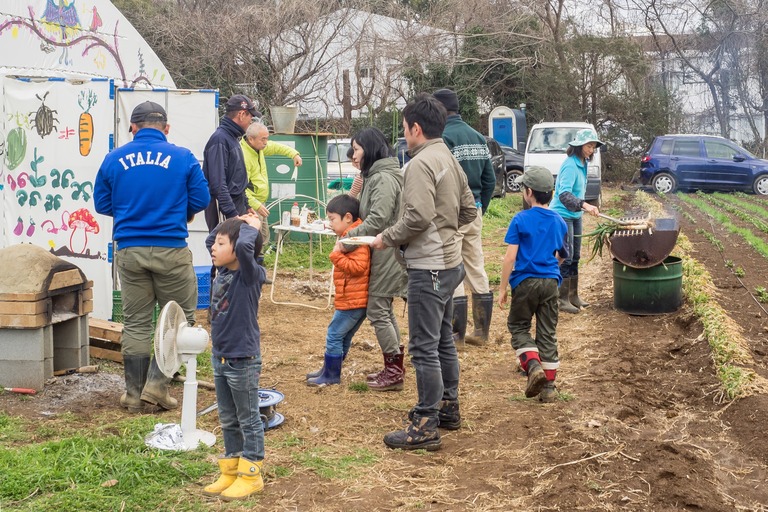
left=0, top=191, right=768, bottom=511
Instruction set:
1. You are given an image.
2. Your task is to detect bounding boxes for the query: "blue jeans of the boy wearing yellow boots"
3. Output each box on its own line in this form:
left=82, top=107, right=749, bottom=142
left=211, top=357, right=264, bottom=462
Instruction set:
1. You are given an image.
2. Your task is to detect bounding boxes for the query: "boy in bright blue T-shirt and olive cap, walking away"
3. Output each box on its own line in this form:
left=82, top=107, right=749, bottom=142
left=499, top=167, right=568, bottom=402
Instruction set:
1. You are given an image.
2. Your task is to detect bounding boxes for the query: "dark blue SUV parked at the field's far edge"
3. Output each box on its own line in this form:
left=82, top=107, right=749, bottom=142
left=640, top=135, right=768, bottom=196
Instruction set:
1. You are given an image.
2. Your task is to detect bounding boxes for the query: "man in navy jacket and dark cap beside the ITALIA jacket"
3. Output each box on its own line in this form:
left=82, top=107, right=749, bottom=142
left=203, top=94, right=261, bottom=231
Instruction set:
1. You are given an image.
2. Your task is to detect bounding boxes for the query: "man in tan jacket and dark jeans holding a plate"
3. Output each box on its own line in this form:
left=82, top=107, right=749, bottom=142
left=373, top=94, right=477, bottom=451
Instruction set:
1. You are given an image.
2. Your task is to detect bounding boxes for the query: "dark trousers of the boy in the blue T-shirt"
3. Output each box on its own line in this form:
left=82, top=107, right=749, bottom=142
left=507, top=277, right=559, bottom=363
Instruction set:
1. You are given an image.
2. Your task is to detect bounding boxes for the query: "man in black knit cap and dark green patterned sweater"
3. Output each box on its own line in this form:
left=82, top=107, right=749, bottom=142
left=433, top=89, right=496, bottom=345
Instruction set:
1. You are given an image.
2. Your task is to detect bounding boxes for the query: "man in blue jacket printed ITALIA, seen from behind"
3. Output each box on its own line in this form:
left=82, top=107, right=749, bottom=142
left=93, top=101, right=211, bottom=412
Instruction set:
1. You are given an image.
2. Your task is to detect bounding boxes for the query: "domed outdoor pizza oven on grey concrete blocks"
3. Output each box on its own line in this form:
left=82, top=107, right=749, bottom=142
left=0, top=244, right=93, bottom=391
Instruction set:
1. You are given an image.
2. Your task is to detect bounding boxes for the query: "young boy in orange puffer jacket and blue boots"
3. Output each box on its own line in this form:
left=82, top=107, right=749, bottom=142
left=307, top=194, right=371, bottom=386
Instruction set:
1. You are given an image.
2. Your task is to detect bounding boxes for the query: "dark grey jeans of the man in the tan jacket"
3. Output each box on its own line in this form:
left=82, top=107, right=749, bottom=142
left=408, top=264, right=465, bottom=418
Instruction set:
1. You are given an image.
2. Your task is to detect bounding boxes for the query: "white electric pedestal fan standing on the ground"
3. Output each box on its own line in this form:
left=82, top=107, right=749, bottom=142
left=155, top=301, right=216, bottom=450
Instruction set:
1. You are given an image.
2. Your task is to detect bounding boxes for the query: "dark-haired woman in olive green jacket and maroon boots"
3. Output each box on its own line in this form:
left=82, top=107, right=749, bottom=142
left=349, top=128, right=408, bottom=391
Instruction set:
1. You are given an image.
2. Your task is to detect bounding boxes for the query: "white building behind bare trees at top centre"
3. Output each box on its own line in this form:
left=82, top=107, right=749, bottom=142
left=255, top=9, right=461, bottom=119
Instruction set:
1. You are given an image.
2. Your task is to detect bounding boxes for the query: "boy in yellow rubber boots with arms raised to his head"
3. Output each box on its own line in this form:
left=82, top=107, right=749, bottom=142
left=203, top=213, right=267, bottom=501
